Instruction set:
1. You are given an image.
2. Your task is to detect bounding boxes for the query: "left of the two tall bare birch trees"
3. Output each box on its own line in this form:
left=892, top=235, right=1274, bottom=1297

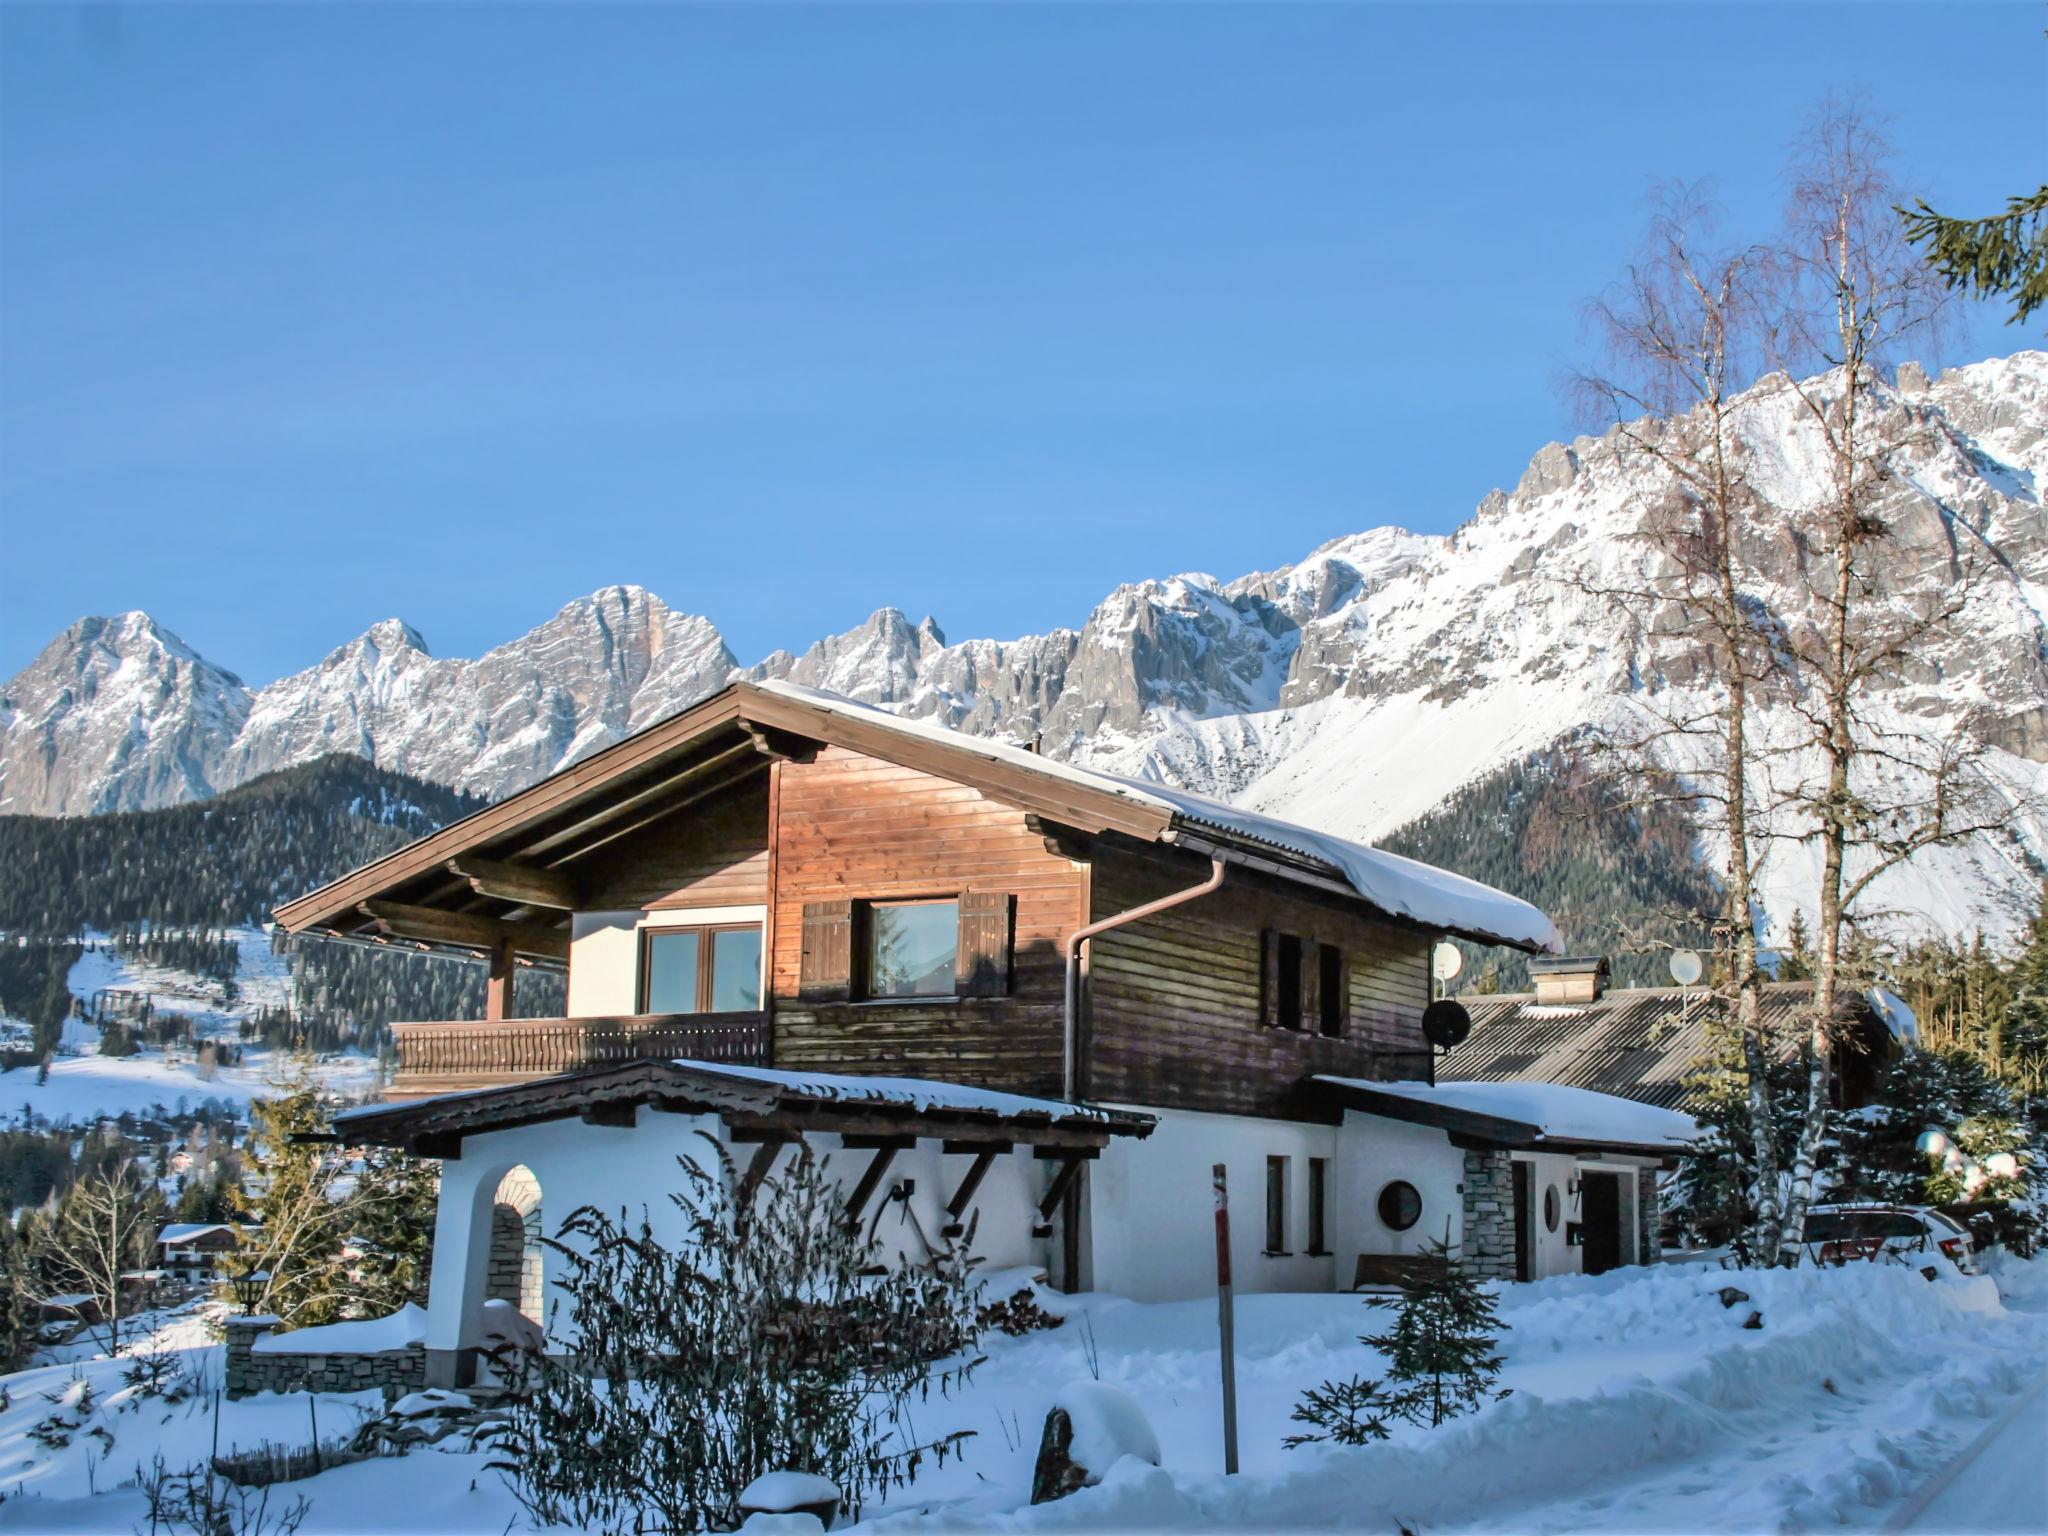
left=1577, top=186, right=1782, bottom=1251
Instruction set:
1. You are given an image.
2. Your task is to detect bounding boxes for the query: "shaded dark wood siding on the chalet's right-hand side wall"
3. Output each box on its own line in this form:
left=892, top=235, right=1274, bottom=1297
left=1085, top=842, right=1430, bottom=1118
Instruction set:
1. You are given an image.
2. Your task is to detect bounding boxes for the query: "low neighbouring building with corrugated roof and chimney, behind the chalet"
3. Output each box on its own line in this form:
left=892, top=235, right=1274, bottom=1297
left=1436, top=956, right=1919, bottom=1110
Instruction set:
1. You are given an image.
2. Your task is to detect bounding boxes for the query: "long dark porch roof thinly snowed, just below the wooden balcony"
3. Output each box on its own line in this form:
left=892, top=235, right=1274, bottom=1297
left=321, top=1061, right=1155, bottom=1157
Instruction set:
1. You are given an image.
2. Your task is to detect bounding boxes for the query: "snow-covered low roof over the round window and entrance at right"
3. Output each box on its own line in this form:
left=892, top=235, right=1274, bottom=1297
left=1315, top=1077, right=1698, bottom=1157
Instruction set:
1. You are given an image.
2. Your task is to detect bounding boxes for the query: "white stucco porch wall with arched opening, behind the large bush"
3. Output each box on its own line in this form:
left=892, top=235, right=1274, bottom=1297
left=426, top=1108, right=1053, bottom=1350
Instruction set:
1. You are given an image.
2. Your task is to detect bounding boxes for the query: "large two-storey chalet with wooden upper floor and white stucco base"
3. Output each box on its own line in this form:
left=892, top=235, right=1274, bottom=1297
left=279, top=684, right=1679, bottom=1380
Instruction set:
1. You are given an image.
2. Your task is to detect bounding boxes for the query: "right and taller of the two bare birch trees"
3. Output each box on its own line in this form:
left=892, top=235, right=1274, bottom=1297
left=1776, top=102, right=2011, bottom=1264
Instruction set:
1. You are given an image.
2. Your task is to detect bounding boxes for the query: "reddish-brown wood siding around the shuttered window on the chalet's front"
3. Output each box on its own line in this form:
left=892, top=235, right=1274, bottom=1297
left=772, top=748, right=1085, bottom=1094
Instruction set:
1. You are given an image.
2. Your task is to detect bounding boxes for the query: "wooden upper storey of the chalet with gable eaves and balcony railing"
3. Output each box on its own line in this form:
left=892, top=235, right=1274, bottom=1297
left=279, top=684, right=1540, bottom=1120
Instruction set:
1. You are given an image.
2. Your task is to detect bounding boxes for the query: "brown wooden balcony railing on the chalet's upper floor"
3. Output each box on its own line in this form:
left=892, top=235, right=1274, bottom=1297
left=385, top=1014, right=770, bottom=1100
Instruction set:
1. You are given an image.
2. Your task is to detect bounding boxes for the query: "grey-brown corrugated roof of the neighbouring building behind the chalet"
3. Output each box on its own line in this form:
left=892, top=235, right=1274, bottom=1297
left=1436, top=981, right=1913, bottom=1110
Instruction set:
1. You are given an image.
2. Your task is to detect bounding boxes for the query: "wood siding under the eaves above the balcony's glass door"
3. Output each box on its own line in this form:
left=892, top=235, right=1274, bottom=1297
left=578, top=764, right=768, bottom=911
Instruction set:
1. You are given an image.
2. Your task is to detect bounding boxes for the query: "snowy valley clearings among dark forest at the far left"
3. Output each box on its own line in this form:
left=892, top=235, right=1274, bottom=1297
left=0, top=928, right=377, bottom=1124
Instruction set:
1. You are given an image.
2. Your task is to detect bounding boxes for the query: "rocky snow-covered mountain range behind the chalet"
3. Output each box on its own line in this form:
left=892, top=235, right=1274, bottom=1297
left=0, top=352, right=2048, bottom=946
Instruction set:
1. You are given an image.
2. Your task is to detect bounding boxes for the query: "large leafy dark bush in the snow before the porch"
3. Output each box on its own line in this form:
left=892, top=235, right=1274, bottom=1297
left=494, top=1137, right=979, bottom=1532
